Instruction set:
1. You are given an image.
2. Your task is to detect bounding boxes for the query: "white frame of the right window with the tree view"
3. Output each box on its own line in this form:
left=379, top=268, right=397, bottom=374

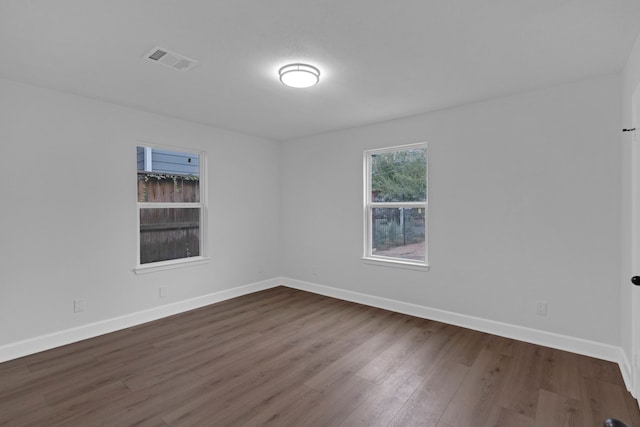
left=362, top=142, right=429, bottom=271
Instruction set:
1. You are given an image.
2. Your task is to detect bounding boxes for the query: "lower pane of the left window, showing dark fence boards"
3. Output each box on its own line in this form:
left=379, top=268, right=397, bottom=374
left=140, top=208, right=200, bottom=264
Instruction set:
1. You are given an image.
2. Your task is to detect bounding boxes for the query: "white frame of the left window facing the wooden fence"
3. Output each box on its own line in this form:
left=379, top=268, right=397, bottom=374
left=132, top=141, right=210, bottom=274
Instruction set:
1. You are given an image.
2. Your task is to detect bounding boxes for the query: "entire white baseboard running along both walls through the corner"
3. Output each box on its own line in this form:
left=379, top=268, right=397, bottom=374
left=0, top=277, right=632, bottom=400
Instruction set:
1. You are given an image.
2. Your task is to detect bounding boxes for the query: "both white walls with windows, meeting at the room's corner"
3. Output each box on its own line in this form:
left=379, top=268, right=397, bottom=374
left=0, top=72, right=624, bottom=362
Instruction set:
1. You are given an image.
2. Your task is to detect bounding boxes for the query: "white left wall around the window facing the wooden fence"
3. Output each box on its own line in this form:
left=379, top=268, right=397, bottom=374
left=0, top=80, right=279, bottom=347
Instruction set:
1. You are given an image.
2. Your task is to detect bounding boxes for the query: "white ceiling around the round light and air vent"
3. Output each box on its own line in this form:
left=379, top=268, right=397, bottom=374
left=0, top=0, right=640, bottom=140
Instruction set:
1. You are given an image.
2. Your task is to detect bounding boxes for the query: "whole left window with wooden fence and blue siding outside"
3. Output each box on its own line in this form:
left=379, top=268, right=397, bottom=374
left=136, top=147, right=205, bottom=268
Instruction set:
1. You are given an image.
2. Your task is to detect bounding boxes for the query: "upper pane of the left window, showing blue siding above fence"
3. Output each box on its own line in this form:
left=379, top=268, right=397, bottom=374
left=137, top=147, right=200, bottom=203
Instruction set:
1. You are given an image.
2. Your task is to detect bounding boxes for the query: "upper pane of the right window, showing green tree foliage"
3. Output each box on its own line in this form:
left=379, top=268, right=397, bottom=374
left=371, top=148, right=427, bottom=202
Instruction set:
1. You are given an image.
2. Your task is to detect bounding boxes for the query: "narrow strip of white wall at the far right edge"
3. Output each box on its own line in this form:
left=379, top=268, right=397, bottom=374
left=620, top=31, right=640, bottom=382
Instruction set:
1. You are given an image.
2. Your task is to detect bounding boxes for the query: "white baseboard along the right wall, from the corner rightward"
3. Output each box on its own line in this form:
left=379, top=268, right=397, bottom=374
left=279, top=277, right=632, bottom=391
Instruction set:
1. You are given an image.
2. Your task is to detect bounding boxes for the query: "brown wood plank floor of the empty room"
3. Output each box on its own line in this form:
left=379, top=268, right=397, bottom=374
left=0, top=288, right=640, bottom=427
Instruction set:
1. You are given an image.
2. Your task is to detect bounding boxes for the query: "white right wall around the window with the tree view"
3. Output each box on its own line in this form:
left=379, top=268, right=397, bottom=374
left=281, top=76, right=621, bottom=345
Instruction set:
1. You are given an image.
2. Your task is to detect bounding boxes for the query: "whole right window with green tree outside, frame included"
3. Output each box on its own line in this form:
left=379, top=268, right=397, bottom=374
left=364, top=143, right=428, bottom=267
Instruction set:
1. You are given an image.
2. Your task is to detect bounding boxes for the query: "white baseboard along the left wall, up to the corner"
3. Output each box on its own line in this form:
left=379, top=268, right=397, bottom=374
left=0, top=279, right=281, bottom=362
